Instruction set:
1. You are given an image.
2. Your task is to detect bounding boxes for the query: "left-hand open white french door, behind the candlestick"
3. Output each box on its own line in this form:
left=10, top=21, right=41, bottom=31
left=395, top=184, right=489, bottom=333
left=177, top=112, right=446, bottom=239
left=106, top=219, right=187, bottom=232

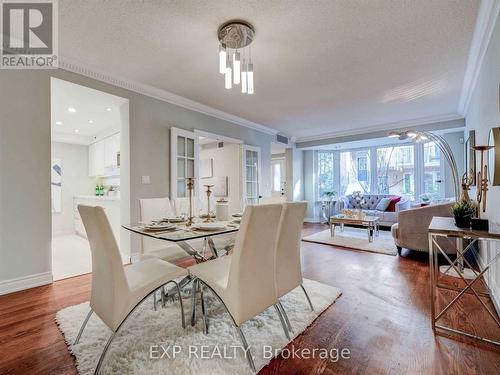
left=170, top=128, right=199, bottom=199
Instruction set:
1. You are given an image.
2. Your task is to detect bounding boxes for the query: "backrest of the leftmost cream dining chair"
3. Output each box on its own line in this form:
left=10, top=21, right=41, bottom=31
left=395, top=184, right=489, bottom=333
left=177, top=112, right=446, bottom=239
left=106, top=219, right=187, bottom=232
left=78, top=204, right=128, bottom=327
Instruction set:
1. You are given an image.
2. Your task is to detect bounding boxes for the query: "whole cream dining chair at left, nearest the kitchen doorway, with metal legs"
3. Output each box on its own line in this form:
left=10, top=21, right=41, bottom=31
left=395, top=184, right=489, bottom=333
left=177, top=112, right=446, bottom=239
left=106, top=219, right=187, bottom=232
left=74, top=205, right=187, bottom=374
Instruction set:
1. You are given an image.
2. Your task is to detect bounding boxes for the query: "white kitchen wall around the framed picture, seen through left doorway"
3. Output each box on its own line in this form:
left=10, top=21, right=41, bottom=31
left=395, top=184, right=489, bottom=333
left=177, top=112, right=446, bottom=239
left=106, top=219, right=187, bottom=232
left=51, top=142, right=95, bottom=235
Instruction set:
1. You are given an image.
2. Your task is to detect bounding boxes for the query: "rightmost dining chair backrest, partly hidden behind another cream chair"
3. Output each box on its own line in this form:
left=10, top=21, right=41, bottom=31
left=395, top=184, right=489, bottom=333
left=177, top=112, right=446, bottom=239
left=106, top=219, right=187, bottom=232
left=276, top=202, right=307, bottom=297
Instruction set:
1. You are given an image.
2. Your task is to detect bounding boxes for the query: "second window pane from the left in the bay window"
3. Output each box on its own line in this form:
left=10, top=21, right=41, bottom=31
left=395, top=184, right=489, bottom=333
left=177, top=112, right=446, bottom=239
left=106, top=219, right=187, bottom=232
left=340, top=150, right=370, bottom=195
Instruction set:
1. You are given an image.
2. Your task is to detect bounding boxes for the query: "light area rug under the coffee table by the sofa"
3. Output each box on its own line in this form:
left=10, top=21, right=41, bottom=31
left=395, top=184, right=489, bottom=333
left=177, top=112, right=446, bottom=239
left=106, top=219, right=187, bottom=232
left=302, top=227, right=398, bottom=255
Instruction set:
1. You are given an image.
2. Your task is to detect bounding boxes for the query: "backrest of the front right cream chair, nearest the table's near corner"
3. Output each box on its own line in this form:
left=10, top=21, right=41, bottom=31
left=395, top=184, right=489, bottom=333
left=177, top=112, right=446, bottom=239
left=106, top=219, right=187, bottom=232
left=227, top=204, right=282, bottom=325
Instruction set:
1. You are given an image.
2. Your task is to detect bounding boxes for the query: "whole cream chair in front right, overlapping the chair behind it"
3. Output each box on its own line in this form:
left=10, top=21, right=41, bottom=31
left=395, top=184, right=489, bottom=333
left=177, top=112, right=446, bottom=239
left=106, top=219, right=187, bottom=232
left=188, top=204, right=289, bottom=371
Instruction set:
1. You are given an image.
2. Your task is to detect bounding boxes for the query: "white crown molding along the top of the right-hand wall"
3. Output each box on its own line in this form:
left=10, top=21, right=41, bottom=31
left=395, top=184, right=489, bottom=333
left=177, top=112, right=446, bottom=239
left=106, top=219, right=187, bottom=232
left=458, top=0, right=500, bottom=116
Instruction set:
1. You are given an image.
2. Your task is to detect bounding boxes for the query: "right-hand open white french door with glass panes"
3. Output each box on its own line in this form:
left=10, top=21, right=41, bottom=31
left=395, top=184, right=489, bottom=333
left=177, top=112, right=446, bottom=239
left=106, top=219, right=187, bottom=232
left=242, top=145, right=261, bottom=206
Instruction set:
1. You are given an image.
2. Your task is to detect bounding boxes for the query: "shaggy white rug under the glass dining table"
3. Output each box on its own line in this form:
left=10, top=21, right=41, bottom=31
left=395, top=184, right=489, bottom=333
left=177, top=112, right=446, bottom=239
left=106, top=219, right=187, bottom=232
left=56, top=279, right=341, bottom=375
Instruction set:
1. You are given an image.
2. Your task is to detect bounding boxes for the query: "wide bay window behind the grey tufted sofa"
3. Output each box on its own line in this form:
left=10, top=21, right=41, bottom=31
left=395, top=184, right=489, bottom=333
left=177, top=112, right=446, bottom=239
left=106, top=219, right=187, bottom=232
left=317, top=142, right=445, bottom=201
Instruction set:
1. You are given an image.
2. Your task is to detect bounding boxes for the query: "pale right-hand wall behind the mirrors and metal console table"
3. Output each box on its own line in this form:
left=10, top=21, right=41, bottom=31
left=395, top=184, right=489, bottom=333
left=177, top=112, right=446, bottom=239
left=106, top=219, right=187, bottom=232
left=466, top=12, right=500, bottom=308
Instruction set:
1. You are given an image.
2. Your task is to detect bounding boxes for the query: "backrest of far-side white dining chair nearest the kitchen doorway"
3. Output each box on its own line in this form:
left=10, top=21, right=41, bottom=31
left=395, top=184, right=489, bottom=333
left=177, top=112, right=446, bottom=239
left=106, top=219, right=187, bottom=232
left=139, top=198, right=176, bottom=253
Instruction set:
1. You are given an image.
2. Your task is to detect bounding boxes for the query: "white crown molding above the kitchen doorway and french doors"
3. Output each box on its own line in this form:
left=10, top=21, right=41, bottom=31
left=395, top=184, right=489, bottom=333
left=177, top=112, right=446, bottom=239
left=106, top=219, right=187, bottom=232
left=59, top=56, right=278, bottom=135
